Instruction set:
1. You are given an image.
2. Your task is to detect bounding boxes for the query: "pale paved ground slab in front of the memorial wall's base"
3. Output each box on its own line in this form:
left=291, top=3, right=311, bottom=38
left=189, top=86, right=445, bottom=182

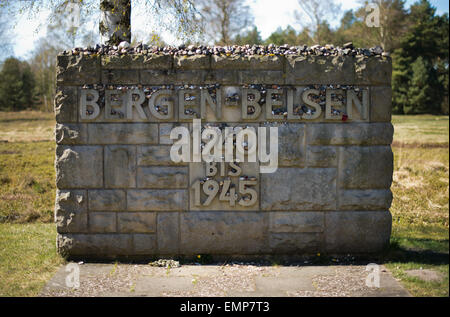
left=40, top=264, right=410, bottom=297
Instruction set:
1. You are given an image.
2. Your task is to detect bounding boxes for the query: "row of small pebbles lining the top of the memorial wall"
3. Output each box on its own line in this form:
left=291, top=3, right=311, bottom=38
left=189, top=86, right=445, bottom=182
left=57, top=41, right=389, bottom=57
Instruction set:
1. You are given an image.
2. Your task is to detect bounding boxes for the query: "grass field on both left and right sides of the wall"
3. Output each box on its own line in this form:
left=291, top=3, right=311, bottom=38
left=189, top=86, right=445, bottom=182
left=0, top=112, right=449, bottom=296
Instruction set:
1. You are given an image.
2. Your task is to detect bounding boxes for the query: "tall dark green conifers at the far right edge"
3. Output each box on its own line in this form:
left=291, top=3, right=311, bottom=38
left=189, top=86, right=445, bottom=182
left=392, top=0, right=449, bottom=114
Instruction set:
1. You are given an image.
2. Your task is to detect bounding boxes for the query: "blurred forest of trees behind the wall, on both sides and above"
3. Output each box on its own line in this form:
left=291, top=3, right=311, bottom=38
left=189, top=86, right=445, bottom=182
left=0, top=0, right=449, bottom=114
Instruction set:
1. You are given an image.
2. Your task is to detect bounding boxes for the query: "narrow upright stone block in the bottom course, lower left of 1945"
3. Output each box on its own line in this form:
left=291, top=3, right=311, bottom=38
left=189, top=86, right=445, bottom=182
left=157, top=212, right=180, bottom=254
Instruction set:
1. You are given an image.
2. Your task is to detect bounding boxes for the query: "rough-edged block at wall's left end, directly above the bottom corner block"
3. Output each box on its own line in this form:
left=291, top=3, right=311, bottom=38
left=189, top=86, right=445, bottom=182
left=55, top=190, right=87, bottom=233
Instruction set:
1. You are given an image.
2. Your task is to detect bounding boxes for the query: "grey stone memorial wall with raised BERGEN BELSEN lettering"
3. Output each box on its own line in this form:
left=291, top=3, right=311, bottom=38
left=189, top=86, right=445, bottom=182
left=55, top=47, right=393, bottom=258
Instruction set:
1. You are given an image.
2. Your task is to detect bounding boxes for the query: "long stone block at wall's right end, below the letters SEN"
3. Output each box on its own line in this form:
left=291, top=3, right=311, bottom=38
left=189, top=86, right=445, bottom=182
left=306, top=123, right=394, bottom=145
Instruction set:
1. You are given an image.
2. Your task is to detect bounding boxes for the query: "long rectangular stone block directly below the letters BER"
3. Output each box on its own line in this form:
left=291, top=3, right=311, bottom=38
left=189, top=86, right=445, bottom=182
left=88, top=123, right=158, bottom=144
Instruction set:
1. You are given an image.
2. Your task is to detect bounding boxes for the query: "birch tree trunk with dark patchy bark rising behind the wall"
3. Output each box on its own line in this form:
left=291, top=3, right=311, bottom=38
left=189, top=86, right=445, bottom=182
left=99, top=0, right=131, bottom=45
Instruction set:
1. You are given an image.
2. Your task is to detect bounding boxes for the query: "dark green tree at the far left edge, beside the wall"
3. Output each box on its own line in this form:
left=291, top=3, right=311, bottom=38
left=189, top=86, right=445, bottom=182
left=0, top=57, right=35, bottom=111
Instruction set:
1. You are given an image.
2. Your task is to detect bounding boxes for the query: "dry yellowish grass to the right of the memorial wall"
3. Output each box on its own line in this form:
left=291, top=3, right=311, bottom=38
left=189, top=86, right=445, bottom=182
left=386, top=115, right=449, bottom=296
